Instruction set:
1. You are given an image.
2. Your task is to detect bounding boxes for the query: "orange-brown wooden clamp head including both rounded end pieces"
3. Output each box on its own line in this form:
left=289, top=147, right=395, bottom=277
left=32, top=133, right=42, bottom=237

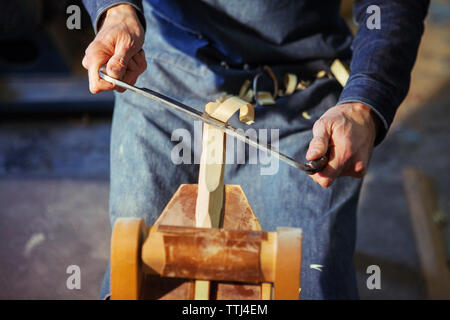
left=111, top=218, right=301, bottom=300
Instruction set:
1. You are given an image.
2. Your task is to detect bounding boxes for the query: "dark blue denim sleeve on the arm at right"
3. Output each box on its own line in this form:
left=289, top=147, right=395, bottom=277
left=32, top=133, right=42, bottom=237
left=338, top=0, right=429, bottom=144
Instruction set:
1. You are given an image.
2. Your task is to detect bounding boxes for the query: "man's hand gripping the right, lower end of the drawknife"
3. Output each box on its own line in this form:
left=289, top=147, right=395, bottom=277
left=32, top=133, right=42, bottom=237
left=306, top=103, right=378, bottom=188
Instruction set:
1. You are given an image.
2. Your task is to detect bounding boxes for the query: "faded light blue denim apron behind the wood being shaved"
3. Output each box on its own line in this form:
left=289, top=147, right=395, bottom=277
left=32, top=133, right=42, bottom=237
left=96, top=4, right=361, bottom=299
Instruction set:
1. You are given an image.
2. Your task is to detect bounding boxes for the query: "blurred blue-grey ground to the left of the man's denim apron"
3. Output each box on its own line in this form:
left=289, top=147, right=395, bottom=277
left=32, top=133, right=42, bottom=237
left=0, top=117, right=111, bottom=299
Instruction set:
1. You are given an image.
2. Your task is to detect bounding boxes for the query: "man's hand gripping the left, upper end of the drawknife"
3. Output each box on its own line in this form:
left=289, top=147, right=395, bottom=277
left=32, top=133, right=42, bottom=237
left=82, top=4, right=147, bottom=93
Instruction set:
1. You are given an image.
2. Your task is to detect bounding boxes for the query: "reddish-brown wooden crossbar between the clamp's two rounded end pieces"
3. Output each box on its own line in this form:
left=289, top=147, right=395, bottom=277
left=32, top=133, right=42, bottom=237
left=142, top=225, right=276, bottom=283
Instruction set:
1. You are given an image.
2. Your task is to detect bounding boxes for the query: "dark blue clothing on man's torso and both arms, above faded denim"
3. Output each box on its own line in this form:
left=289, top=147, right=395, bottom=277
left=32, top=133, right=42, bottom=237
left=84, top=0, right=429, bottom=144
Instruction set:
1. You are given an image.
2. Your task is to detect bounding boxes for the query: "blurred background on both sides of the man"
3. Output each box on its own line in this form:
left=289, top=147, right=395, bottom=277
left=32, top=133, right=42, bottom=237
left=0, top=0, right=450, bottom=299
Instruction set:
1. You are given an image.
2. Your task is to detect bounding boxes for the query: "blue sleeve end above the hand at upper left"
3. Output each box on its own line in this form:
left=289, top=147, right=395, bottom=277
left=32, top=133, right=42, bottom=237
left=83, top=0, right=145, bottom=34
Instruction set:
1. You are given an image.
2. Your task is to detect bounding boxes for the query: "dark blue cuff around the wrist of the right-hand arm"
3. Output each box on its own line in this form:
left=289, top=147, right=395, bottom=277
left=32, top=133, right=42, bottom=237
left=336, top=74, right=399, bottom=145
